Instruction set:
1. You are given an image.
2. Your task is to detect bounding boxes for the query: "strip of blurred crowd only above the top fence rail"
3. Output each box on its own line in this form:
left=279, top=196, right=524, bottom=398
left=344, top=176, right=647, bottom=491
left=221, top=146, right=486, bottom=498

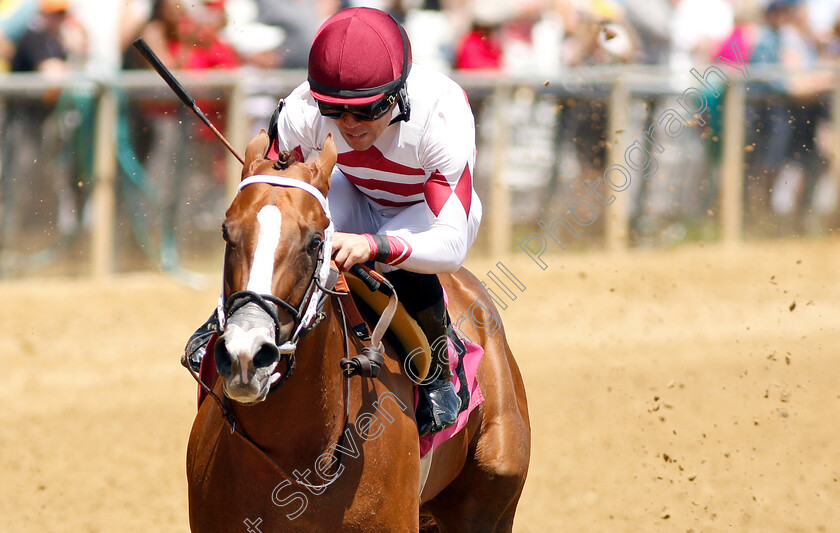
left=0, top=0, right=840, bottom=75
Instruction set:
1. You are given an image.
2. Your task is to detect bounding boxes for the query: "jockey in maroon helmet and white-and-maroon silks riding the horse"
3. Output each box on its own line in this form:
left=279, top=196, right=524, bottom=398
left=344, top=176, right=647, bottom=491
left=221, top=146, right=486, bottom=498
left=186, top=8, right=481, bottom=436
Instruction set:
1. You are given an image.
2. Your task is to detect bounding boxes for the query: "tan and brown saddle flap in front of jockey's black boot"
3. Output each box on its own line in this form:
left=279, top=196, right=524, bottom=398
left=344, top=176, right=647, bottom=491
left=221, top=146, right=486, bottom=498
left=344, top=272, right=432, bottom=380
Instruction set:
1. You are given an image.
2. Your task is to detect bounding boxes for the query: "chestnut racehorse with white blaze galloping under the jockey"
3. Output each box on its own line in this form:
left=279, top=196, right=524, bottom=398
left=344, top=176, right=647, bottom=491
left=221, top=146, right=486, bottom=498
left=186, top=130, right=530, bottom=533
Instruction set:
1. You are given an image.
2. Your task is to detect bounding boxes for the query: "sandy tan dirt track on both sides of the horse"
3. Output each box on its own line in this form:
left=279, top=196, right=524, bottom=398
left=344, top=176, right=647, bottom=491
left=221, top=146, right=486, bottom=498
left=0, top=240, right=840, bottom=533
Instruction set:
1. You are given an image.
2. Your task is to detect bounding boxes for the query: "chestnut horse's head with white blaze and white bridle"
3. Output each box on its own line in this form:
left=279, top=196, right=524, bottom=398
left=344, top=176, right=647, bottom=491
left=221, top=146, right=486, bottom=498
left=215, top=130, right=336, bottom=404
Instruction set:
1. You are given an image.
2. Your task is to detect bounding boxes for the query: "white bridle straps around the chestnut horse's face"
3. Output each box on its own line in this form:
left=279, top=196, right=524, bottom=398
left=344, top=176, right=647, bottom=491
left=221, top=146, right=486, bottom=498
left=216, top=174, right=343, bottom=386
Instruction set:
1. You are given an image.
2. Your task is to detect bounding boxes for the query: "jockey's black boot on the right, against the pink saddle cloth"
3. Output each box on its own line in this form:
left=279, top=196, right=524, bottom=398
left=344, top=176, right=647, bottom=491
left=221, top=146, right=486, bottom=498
left=386, top=270, right=461, bottom=437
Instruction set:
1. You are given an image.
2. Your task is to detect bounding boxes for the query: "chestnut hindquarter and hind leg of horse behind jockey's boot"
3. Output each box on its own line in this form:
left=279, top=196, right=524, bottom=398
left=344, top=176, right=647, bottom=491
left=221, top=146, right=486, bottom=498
left=424, top=269, right=531, bottom=532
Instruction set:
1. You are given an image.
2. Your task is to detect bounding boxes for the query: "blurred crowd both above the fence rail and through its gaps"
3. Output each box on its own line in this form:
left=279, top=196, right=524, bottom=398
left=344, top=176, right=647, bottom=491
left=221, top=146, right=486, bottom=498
left=0, top=0, right=840, bottom=274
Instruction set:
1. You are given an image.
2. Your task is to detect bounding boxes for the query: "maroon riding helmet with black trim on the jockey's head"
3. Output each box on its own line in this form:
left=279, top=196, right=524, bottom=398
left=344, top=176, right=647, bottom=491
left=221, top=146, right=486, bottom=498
left=308, top=7, right=411, bottom=115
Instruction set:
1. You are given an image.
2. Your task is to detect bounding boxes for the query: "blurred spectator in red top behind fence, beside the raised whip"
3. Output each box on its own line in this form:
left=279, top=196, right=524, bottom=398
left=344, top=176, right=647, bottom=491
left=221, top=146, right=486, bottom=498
left=120, top=0, right=241, bottom=271
